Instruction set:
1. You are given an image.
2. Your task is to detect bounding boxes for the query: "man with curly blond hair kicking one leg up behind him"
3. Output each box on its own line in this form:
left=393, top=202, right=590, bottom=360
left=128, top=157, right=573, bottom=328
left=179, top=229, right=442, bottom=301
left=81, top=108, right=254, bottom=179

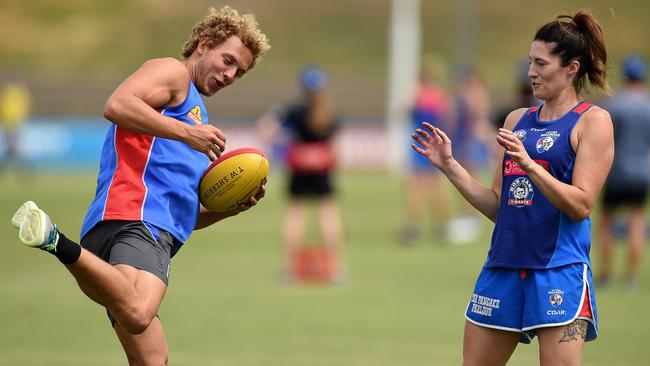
left=12, top=7, right=270, bottom=365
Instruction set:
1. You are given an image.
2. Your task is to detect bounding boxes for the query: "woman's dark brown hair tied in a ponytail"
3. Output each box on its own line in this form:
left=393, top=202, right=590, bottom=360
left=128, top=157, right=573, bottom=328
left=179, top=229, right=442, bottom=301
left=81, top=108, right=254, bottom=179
left=534, top=10, right=610, bottom=93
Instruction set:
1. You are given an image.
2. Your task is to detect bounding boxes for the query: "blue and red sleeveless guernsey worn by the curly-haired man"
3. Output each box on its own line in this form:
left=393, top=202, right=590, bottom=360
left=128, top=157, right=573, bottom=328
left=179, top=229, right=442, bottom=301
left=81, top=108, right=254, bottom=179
left=81, top=82, right=209, bottom=253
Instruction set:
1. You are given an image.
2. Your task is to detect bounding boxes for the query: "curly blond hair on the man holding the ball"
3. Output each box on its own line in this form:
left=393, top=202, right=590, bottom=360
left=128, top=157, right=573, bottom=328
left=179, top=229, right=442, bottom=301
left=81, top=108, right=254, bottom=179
left=181, top=6, right=271, bottom=70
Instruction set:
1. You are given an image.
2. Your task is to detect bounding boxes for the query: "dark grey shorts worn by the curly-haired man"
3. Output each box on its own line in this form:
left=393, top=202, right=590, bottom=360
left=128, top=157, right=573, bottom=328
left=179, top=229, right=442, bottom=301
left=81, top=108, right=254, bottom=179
left=81, top=220, right=174, bottom=286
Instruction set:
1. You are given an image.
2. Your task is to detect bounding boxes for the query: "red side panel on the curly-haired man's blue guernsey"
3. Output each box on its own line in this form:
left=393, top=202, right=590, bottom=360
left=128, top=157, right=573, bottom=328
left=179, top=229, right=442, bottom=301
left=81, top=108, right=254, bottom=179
left=102, top=126, right=154, bottom=220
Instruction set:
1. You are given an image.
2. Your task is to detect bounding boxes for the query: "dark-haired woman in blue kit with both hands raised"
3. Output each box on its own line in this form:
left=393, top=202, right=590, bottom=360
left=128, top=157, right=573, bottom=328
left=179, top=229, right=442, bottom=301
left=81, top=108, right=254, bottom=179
left=412, top=11, right=614, bottom=366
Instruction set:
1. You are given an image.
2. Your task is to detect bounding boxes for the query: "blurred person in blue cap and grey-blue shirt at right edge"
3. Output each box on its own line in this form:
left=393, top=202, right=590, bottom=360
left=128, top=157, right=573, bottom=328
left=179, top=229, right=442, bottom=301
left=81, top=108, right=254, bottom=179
left=598, top=56, right=650, bottom=290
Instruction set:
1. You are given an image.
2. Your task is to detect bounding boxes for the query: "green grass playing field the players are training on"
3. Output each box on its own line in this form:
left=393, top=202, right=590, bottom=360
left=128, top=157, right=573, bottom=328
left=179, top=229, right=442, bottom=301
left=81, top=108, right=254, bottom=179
left=0, top=175, right=650, bottom=366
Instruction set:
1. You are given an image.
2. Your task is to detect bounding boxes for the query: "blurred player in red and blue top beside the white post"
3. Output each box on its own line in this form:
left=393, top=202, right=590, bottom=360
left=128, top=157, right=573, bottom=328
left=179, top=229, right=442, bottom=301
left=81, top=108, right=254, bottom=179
left=400, top=55, right=452, bottom=245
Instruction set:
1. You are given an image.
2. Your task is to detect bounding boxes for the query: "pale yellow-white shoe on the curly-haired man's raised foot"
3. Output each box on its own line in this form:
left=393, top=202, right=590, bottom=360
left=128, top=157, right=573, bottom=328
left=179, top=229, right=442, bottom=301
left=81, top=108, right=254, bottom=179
left=11, top=201, right=59, bottom=251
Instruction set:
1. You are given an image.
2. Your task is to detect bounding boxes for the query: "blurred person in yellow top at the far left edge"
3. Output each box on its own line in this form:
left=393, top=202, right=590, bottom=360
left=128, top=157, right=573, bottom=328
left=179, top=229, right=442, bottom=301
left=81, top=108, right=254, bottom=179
left=0, top=78, right=32, bottom=174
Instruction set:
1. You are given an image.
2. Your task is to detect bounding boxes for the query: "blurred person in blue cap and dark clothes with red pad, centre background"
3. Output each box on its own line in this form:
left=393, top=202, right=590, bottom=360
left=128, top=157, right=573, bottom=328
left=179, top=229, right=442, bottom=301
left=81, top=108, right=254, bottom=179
left=259, top=66, right=343, bottom=282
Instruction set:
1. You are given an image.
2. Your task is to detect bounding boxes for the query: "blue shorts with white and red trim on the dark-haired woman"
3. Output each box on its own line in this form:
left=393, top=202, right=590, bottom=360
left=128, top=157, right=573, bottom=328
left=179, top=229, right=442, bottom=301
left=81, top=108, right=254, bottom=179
left=465, top=263, right=598, bottom=343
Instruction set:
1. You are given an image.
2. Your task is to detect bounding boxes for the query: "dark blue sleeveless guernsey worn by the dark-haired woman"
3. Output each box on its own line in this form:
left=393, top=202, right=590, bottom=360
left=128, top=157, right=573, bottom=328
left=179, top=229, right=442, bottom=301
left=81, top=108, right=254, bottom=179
left=485, top=102, right=592, bottom=269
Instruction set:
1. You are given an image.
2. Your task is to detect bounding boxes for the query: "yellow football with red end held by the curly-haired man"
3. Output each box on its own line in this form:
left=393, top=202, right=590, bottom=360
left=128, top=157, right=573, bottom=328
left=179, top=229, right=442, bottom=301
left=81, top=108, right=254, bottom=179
left=199, top=147, right=269, bottom=212
